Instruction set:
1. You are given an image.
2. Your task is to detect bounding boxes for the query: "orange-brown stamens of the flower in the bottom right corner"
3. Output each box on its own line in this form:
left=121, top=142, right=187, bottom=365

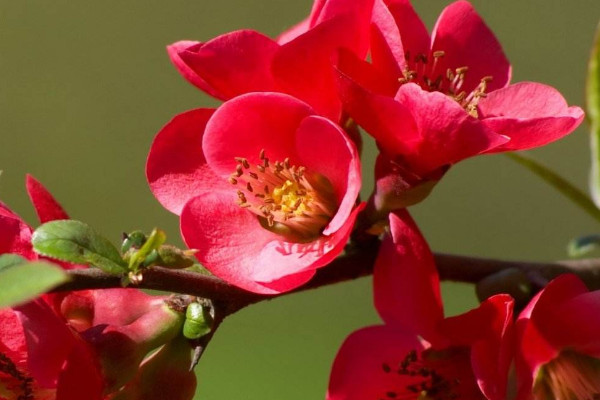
left=533, top=350, right=600, bottom=400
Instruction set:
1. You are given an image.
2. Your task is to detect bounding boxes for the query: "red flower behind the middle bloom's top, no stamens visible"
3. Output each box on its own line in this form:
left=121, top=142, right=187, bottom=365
left=168, top=0, right=373, bottom=121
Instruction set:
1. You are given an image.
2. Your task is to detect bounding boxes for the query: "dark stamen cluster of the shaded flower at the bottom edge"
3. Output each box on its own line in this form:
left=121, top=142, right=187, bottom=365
left=381, top=350, right=460, bottom=400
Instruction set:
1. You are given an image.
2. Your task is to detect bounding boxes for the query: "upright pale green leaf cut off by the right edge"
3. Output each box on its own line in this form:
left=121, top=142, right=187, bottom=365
left=585, top=24, right=600, bottom=207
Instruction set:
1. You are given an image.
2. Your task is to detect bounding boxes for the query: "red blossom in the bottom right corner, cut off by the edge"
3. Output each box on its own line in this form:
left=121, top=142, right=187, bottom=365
left=516, top=275, right=600, bottom=400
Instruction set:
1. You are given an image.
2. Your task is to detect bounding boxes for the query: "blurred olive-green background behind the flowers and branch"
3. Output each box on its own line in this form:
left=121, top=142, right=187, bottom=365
left=0, top=0, right=600, bottom=400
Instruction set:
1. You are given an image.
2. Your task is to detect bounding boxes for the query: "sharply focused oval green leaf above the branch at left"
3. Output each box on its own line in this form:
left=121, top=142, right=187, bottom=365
left=31, top=220, right=127, bottom=275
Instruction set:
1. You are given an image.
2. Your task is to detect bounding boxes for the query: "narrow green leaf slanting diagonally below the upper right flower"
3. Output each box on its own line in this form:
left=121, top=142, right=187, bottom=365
left=504, top=153, right=600, bottom=222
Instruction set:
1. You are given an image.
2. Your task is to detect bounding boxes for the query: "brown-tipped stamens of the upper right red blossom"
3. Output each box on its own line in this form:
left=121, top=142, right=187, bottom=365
left=398, top=51, right=492, bottom=118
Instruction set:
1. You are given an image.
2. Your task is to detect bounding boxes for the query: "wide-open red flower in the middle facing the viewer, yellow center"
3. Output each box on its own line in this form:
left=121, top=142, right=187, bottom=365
left=146, top=93, right=360, bottom=293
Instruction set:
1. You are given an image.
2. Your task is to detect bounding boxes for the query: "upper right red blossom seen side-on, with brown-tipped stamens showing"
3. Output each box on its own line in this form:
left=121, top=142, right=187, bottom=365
left=338, top=0, right=583, bottom=209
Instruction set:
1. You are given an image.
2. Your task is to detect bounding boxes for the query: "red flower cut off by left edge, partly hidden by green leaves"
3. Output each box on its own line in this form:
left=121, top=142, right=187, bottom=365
left=0, top=176, right=103, bottom=400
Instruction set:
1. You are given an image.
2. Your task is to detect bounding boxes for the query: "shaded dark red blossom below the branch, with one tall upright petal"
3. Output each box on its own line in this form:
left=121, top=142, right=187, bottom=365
left=327, top=212, right=513, bottom=400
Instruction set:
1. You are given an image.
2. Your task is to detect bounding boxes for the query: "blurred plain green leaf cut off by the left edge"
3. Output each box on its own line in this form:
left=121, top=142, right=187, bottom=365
left=0, top=261, right=69, bottom=308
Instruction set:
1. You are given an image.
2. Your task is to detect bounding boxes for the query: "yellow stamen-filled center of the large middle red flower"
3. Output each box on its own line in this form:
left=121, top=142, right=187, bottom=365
left=229, top=150, right=337, bottom=242
